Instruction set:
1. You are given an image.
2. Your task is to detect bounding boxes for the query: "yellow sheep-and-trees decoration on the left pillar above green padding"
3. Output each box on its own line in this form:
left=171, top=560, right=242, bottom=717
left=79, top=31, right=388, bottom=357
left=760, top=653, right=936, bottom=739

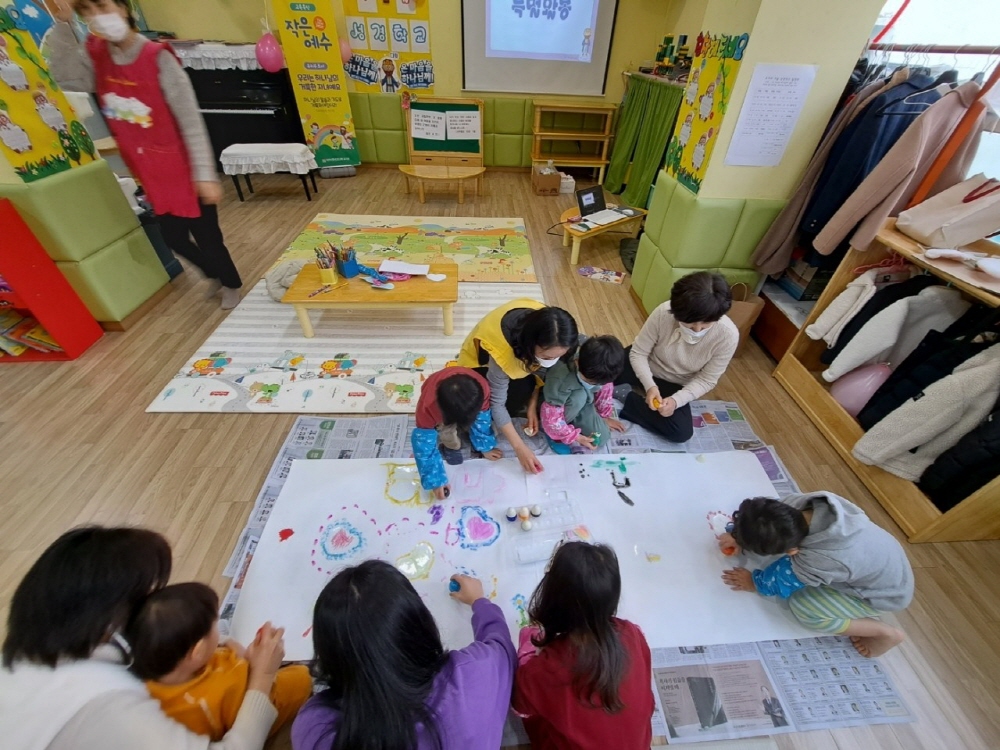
left=0, top=7, right=97, bottom=182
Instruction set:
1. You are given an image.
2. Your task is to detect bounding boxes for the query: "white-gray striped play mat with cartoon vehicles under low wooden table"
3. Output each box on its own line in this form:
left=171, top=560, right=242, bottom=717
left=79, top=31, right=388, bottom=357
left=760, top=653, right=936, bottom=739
left=146, top=281, right=543, bottom=414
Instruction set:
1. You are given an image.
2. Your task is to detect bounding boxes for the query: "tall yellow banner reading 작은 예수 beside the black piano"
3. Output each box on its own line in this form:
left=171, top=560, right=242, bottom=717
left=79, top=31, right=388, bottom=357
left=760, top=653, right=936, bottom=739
left=273, top=0, right=361, bottom=167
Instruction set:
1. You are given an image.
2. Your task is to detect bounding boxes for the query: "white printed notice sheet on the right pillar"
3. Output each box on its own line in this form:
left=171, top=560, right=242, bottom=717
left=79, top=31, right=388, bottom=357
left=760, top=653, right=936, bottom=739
left=726, top=64, right=816, bottom=167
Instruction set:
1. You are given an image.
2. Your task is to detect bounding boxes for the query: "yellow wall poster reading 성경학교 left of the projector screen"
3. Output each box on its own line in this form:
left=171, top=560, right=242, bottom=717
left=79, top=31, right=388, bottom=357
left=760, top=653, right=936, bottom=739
left=344, top=0, right=434, bottom=94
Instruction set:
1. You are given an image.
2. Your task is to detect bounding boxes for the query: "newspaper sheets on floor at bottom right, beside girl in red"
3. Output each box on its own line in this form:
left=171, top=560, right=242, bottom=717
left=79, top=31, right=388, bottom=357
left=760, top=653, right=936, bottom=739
left=653, top=636, right=913, bottom=745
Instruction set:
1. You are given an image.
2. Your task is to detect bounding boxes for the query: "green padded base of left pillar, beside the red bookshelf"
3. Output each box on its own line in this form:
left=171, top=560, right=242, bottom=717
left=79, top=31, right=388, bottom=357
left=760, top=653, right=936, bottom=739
left=0, top=159, right=170, bottom=323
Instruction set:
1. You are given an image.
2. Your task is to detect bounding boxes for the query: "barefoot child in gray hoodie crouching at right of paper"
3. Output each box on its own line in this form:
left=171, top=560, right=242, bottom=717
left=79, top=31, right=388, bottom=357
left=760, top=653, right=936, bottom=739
left=719, top=492, right=913, bottom=656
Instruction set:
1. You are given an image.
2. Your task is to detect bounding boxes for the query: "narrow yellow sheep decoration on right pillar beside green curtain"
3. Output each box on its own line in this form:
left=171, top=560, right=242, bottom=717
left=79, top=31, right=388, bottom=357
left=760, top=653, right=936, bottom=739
left=667, top=31, right=750, bottom=193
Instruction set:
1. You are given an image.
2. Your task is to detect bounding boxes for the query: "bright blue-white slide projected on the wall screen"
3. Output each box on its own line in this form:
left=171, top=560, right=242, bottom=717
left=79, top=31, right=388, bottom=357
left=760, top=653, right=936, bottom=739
left=486, top=0, right=600, bottom=63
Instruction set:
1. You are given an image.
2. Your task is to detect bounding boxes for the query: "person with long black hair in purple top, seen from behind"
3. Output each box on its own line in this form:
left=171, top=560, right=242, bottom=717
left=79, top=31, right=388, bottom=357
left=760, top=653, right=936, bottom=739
left=292, top=560, right=516, bottom=750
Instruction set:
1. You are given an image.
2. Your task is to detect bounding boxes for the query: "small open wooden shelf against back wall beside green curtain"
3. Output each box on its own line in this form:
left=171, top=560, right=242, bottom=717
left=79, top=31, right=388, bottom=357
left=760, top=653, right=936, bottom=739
left=531, top=99, right=618, bottom=183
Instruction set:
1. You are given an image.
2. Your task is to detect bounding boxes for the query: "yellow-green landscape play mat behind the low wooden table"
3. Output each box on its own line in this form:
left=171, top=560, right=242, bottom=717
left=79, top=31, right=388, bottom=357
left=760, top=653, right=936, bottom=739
left=278, top=214, right=537, bottom=283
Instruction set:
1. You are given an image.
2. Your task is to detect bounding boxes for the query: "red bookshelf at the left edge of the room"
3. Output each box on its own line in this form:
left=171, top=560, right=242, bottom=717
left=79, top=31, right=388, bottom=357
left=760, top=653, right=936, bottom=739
left=0, top=198, right=104, bottom=364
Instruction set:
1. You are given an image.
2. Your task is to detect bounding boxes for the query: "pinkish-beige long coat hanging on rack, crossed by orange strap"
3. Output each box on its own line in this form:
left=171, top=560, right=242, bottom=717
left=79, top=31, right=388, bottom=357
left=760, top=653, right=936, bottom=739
left=813, top=81, right=985, bottom=255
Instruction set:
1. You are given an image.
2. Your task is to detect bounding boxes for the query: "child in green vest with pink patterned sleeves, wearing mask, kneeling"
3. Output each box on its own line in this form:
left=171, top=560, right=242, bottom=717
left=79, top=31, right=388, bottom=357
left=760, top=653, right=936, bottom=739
left=541, top=336, right=625, bottom=454
